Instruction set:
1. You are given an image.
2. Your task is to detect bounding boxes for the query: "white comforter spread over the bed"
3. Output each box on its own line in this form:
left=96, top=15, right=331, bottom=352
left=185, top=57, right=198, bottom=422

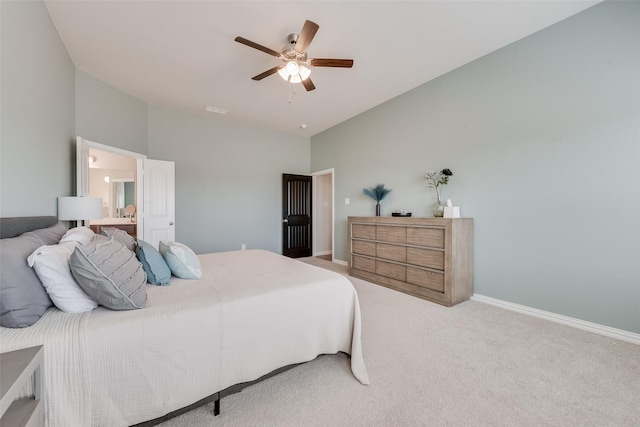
left=0, top=250, right=369, bottom=427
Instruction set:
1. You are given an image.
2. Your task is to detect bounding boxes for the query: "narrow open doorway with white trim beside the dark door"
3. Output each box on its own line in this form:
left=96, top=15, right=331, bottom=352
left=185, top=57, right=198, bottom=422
left=311, top=168, right=335, bottom=261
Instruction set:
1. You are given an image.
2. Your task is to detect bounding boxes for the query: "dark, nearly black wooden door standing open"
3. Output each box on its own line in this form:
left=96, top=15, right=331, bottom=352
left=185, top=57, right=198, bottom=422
left=282, top=173, right=311, bottom=258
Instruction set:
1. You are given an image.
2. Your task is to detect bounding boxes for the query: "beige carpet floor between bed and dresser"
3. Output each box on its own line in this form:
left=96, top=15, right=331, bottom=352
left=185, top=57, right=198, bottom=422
left=161, top=258, right=640, bottom=427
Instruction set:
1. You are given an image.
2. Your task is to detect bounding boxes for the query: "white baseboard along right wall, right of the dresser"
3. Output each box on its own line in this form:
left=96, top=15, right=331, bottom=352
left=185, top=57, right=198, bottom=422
left=471, top=294, right=640, bottom=345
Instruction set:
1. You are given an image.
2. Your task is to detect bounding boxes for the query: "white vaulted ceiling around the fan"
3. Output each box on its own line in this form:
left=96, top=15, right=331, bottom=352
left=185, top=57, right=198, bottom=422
left=45, top=0, right=599, bottom=136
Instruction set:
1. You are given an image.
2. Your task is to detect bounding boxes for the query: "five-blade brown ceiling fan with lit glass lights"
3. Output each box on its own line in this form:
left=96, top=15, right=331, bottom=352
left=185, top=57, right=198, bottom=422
left=235, top=20, right=353, bottom=91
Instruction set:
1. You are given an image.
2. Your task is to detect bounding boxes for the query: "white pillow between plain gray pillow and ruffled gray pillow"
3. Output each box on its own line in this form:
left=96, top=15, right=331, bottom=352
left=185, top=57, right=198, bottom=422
left=27, top=242, right=98, bottom=313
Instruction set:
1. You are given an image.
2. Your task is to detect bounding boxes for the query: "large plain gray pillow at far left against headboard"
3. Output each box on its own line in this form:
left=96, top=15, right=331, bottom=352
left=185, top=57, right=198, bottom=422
left=0, top=222, right=67, bottom=328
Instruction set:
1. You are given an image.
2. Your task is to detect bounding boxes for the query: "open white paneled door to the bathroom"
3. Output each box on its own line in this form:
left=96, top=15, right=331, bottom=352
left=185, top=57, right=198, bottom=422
left=143, top=159, right=176, bottom=249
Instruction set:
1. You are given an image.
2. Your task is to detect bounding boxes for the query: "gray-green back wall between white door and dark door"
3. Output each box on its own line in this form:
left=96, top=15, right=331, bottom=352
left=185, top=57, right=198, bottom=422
left=149, top=107, right=310, bottom=253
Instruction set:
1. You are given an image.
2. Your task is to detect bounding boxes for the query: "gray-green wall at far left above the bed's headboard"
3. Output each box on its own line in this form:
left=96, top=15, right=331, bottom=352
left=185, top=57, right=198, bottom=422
left=0, top=1, right=75, bottom=217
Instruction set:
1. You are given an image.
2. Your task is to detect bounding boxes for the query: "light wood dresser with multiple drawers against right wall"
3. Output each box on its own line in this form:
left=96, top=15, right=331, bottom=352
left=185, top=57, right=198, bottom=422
left=348, top=216, right=473, bottom=307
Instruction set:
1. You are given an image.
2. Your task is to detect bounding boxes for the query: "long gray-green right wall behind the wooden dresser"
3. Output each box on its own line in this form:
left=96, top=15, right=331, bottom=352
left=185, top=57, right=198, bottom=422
left=311, top=2, right=640, bottom=333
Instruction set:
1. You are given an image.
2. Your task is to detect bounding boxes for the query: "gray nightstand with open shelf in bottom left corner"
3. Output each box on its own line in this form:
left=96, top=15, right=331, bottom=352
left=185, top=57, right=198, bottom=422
left=0, top=345, right=44, bottom=427
